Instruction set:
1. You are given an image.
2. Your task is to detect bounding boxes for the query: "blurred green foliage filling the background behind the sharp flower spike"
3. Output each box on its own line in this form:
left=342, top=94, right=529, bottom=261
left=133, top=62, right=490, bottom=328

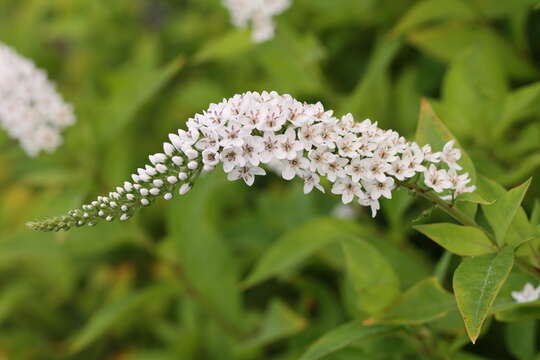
left=0, top=0, right=540, bottom=360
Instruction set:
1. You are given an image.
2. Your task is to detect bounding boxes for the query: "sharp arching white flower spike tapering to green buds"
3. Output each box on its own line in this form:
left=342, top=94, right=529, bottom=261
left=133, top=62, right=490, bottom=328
left=28, top=92, right=474, bottom=231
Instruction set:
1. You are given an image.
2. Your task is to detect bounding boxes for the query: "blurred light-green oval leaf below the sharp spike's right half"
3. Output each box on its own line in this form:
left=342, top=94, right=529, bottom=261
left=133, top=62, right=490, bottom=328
left=342, top=239, right=399, bottom=314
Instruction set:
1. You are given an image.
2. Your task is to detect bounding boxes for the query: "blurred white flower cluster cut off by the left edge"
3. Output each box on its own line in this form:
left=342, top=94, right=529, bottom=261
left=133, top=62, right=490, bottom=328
left=0, top=43, right=75, bottom=156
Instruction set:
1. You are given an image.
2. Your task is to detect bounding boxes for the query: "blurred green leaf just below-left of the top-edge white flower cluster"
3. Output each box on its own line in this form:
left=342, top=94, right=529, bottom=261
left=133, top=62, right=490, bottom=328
left=193, top=30, right=255, bottom=63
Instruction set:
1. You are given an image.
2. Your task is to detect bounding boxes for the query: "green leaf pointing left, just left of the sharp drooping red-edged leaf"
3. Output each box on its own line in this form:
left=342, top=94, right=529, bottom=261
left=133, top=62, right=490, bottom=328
left=373, top=278, right=456, bottom=325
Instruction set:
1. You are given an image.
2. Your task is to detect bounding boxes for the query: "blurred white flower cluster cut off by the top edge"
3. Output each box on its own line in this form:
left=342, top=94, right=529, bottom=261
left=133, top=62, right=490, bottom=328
left=223, top=0, right=291, bottom=43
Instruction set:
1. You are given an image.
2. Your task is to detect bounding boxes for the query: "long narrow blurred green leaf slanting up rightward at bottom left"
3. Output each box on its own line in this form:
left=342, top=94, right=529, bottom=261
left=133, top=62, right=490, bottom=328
left=69, top=285, right=170, bottom=353
